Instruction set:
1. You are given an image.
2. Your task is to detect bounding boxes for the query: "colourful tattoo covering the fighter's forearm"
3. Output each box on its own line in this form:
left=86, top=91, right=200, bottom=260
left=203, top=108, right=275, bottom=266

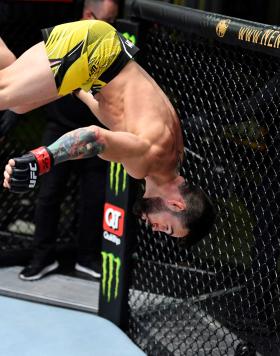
left=48, top=128, right=105, bottom=164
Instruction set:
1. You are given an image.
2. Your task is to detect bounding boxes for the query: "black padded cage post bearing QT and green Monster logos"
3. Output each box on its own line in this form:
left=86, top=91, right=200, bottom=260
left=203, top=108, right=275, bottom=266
left=99, top=162, right=138, bottom=329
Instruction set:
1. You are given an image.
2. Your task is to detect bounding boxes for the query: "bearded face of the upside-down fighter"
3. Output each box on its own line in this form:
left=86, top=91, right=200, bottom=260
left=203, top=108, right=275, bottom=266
left=133, top=197, right=188, bottom=237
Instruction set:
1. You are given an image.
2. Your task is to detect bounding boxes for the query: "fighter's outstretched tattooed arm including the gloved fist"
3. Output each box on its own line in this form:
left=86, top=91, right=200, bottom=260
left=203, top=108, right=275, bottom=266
left=3, top=126, right=151, bottom=193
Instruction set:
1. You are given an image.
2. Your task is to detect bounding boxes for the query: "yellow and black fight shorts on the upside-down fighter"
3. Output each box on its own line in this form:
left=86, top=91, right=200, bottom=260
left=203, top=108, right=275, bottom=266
left=42, top=20, right=139, bottom=95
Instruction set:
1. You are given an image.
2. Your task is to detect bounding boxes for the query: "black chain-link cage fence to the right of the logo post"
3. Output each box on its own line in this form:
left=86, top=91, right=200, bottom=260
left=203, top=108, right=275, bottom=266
left=128, top=4, right=280, bottom=356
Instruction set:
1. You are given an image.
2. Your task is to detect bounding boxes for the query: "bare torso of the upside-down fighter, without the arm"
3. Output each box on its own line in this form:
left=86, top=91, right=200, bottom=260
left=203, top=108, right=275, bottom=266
left=95, top=61, right=184, bottom=177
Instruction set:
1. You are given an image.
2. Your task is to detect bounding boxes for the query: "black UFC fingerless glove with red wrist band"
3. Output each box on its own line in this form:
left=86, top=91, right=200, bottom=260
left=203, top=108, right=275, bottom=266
left=10, top=146, right=53, bottom=193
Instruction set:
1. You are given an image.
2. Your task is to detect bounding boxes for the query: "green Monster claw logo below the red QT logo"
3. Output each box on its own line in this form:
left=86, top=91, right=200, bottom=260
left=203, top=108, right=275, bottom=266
left=101, top=251, right=121, bottom=303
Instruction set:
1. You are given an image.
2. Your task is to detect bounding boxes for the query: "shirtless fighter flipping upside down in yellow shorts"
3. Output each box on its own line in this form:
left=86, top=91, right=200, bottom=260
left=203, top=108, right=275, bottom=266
left=0, top=20, right=214, bottom=243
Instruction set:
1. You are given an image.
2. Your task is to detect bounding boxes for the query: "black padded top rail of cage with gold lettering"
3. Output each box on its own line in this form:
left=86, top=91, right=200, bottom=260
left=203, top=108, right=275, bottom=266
left=129, top=0, right=280, bottom=57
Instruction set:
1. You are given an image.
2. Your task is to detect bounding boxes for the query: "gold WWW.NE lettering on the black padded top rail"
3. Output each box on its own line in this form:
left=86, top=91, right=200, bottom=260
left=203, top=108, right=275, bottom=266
left=238, top=26, right=280, bottom=48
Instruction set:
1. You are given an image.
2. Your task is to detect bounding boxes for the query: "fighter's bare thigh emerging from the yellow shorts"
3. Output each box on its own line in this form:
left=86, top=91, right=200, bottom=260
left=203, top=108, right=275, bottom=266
left=0, top=42, right=59, bottom=112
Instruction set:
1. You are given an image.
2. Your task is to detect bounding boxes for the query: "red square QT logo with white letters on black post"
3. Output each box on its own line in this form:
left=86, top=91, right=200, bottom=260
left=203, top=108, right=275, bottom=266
left=103, top=203, right=124, bottom=236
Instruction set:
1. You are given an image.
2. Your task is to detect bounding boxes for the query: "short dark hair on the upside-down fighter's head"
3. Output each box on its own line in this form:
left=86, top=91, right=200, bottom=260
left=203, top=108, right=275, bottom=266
left=178, top=183, right=216, bottom=248
